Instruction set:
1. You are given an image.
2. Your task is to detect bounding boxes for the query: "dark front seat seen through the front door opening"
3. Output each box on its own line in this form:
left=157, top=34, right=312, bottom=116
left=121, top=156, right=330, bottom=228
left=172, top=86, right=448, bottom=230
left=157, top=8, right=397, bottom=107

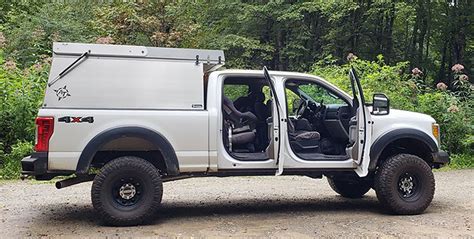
left=288, top=118, right=321, bottom=152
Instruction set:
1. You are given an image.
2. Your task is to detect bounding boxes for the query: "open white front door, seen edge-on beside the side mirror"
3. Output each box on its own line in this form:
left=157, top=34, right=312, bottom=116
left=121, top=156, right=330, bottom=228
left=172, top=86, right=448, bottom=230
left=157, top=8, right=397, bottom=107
left=349, top=68, right=372, bottom=177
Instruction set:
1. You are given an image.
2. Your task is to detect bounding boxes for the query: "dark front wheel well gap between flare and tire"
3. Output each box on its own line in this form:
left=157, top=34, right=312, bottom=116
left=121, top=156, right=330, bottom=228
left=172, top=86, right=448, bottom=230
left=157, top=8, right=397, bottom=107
left=377, top=138, right=433, bottom=169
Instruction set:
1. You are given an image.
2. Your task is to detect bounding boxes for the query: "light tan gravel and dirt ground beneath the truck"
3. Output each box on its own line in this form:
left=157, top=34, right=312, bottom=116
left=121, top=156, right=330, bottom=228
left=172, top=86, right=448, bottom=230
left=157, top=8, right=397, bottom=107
left=0, top=170, right=474, bottom=238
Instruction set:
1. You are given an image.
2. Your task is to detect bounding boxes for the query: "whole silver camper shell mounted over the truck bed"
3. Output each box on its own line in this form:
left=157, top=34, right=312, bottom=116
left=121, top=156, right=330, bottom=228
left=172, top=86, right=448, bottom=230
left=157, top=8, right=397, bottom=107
left=43, top=43, right=225, bottom=110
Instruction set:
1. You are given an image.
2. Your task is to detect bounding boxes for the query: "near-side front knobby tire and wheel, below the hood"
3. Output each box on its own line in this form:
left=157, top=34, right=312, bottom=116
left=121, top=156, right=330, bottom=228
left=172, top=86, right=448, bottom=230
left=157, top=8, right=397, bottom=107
left=375, top=154, right=435, bottom=215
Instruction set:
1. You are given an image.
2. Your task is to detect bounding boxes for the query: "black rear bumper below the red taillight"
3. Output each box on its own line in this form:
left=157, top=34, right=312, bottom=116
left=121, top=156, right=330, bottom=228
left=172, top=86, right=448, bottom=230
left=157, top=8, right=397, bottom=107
left=21, top=152, right=74, bottom=180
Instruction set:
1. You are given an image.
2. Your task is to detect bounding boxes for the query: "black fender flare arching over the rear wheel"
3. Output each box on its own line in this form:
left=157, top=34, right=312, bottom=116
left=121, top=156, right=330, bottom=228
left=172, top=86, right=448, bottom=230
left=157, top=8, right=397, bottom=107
left=76, top=127, right=179, bottom=175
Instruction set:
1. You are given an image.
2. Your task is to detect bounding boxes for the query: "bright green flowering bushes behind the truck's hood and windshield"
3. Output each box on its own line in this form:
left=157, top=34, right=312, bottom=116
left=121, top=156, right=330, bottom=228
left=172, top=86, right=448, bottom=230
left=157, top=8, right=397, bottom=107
left=311, top=56, right=474, bottom=165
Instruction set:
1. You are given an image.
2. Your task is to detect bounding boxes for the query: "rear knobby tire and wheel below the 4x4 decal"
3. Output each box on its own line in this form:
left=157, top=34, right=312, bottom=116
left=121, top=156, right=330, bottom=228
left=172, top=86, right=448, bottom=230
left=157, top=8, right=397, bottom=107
left=91, top=156, right=163, bottom=226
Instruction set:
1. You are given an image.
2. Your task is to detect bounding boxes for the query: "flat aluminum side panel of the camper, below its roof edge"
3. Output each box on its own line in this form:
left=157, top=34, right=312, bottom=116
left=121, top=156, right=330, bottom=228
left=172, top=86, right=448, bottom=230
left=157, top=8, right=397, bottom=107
left=44, top=55, right=204, bottom=109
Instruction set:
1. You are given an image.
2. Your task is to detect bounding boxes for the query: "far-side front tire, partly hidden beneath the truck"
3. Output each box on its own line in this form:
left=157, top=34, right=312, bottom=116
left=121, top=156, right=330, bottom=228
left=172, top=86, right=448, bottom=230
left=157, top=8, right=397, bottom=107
left=328, top=177, right=371, bottom=198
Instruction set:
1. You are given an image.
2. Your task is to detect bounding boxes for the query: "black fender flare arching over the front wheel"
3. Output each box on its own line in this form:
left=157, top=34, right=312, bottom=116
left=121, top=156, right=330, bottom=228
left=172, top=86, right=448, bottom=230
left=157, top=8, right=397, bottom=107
left=369, top=129, right=438, bottom=170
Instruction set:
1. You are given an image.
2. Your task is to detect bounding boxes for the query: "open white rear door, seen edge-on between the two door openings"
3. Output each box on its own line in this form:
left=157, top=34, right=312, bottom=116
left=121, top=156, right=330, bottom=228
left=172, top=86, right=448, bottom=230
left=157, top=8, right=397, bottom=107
left=263, top=66, right=283, bottom=176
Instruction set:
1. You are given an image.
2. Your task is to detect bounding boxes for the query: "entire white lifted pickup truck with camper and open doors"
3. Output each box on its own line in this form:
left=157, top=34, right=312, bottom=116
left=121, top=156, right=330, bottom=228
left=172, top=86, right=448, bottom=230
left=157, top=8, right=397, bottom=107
left=21, top=43, right=449, bottom=225
